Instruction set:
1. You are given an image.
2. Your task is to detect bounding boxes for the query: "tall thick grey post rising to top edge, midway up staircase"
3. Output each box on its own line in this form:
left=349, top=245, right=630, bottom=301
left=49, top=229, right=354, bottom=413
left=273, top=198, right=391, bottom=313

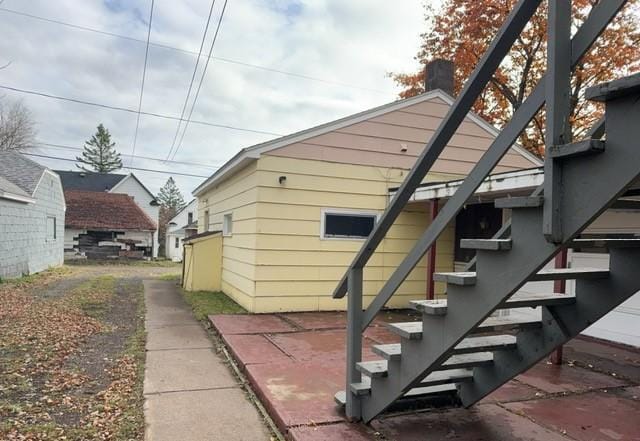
left=542, top=0, right=571, bottom=243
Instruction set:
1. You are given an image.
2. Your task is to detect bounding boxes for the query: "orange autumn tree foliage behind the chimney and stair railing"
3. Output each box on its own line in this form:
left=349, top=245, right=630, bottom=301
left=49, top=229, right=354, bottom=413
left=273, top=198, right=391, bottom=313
left=390, top=0, right=640, bottom=155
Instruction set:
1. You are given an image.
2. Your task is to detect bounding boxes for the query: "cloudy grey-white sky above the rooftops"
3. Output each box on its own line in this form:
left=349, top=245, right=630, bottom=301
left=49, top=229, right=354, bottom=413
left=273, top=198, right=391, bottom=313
left=0, top=0, right=436, bottom=197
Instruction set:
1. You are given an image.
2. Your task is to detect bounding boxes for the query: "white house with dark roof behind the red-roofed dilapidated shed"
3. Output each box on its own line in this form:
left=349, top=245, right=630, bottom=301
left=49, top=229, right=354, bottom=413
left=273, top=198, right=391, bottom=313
left=57, top=170, right=160, bottom=258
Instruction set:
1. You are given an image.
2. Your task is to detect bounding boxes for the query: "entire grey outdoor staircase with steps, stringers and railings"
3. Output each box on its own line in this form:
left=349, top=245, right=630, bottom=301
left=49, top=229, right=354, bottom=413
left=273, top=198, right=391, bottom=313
left=334, top=0, right=640, bottom=422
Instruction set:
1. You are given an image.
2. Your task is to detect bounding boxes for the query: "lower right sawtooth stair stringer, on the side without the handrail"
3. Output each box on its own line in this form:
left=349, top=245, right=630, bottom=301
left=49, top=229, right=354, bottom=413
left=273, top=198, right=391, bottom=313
left=458, top=248, right=640, bottom=407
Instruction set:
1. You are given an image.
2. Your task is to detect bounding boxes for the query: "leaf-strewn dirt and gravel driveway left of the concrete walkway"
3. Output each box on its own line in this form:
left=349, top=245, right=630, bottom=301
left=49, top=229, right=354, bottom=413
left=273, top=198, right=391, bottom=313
left=0, top=266, right=174, bottom=440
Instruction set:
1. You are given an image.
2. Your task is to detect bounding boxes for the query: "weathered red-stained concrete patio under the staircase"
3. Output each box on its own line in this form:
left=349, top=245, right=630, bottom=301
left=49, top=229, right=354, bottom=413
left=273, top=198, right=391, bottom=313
left=210, top=312, right=640, bottom=441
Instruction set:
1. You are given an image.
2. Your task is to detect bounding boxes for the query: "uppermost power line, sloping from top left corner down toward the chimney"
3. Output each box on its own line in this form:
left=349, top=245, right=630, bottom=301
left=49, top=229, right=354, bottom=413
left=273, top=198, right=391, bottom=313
left=0, top=3, right=388, bottom=94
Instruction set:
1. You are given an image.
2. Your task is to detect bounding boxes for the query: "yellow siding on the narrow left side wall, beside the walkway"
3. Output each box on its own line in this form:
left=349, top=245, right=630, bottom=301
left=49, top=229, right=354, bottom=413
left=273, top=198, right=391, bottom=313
left=198, top=162, right=258, bottom=311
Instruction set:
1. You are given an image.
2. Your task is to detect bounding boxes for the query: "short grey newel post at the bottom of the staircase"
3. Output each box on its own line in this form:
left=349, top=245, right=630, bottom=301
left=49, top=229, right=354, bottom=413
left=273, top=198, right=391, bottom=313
left=345, top=267, right=363, bottom=421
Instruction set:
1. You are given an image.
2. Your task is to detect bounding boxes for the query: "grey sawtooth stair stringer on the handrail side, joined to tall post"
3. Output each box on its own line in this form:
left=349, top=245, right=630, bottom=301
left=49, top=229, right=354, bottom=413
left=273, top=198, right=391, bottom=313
left=361, top=90, right=640, bottom=422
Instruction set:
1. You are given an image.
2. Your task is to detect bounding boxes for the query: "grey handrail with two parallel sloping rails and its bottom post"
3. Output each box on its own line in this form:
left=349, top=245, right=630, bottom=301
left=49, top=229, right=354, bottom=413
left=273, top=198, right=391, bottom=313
left=340, top=0, right=628, bottom=418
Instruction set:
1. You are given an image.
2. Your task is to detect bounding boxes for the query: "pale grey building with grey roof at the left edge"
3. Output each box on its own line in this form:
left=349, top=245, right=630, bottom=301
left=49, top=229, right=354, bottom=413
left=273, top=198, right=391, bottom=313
left=0, top=152, right=65, bottom=277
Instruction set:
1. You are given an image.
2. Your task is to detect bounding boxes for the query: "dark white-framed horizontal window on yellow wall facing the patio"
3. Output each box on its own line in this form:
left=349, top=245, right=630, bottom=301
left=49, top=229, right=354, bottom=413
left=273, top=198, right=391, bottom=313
left=321, top=210, right=378, bottom=239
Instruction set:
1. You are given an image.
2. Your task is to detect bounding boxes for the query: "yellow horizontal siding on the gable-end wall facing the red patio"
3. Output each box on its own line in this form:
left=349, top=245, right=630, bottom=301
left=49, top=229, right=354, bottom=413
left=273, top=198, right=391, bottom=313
left=250, top=155, right=454, bottom=312
